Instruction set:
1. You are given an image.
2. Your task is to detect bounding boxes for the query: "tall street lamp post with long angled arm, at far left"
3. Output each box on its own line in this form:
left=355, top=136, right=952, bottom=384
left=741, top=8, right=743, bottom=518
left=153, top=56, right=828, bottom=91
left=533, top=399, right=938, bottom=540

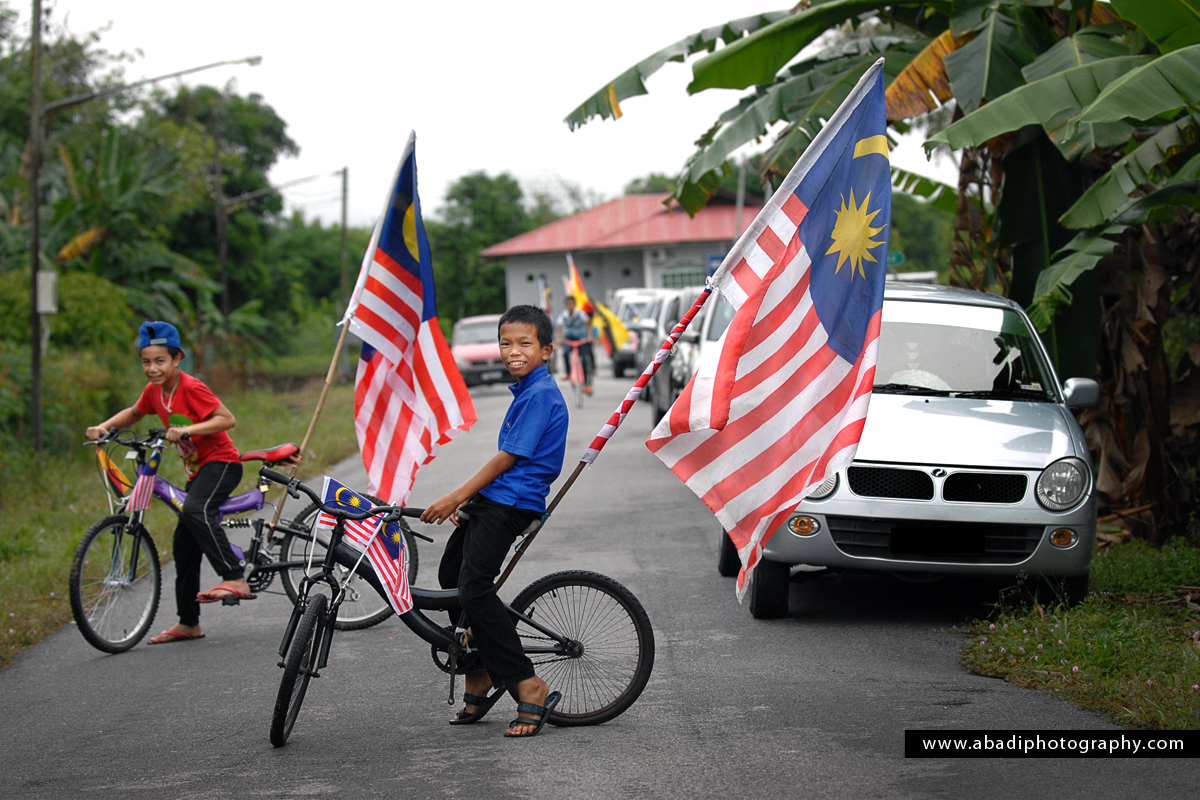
left=29, top=42, right=263, bottom=452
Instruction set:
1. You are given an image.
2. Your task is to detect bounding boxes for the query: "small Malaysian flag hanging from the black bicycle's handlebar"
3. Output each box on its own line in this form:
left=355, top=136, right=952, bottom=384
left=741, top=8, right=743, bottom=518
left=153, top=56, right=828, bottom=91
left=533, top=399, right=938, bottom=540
left=316, top=476, right=413, bottom=614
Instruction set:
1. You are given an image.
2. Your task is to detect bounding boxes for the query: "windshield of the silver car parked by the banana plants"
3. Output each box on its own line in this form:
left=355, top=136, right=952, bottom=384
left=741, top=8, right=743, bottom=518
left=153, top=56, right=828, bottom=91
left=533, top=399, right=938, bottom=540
left=875, top=300, right=1054, bottom=401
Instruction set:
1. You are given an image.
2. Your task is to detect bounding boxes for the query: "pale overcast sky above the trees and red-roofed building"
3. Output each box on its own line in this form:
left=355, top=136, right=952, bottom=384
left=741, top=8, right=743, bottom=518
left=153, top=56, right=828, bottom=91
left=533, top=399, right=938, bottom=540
left=51, top=0, right=954, bottom=225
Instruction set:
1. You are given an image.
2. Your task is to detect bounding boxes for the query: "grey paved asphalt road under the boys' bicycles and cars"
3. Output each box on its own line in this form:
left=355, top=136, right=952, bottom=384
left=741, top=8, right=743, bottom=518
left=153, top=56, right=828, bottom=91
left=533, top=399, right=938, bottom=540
left=0, top=367, right=1200, bottom=800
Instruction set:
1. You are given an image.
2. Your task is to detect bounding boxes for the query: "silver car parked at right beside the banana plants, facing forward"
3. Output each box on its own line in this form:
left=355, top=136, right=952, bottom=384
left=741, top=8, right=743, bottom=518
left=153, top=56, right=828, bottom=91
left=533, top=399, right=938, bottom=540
left=718, top=283, right=1099, bottom=619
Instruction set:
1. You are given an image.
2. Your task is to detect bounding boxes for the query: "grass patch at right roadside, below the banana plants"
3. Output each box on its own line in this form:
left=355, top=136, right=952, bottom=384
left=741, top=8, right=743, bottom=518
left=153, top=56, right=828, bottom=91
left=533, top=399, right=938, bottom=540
left=959, top=541, right=1200, bottom=729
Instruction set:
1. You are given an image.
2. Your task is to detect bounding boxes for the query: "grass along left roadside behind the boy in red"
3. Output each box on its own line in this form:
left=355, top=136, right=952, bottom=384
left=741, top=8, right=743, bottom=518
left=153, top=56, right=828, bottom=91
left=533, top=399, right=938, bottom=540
left=0, top=384, right=358, bottom=667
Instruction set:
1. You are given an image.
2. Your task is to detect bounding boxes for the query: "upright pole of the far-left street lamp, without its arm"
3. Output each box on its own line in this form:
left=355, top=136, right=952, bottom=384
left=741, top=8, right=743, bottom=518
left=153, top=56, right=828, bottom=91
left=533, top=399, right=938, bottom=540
left=29, top=0, right=42, bottom=452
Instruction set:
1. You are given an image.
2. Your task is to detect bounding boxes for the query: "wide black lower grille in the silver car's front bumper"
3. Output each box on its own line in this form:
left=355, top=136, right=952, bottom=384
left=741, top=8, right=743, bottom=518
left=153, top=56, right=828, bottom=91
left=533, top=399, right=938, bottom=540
left=826, top=517, right=1044, bottom=564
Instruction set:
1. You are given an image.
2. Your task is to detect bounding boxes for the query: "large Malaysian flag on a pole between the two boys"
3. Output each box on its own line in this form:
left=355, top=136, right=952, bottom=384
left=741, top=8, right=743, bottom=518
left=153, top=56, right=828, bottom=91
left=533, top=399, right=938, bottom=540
left=343, top=133, right=476, bottom=503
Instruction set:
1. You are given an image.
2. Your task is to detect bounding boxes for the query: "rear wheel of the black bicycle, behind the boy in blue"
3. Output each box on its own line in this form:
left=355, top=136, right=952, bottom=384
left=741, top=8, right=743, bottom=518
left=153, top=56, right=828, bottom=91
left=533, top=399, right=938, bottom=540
left=512, top=570, right=654, bottom=726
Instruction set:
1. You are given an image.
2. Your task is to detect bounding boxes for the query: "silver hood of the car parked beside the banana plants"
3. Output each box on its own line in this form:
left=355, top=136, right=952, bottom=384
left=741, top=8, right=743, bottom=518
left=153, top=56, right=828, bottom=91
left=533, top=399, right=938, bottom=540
left=854, top=395, right=1086, bottom=469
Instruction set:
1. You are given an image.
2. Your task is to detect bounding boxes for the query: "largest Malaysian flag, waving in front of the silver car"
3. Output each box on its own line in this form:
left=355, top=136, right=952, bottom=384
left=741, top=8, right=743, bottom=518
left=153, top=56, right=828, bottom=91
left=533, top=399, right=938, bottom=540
left=647, top=60, right=892, bottom=599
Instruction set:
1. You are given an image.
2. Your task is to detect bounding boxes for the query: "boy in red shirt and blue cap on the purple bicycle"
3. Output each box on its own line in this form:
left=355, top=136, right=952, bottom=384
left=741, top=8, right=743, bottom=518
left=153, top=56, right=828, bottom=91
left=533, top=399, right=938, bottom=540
left=88, top=323, right=257, bottom=644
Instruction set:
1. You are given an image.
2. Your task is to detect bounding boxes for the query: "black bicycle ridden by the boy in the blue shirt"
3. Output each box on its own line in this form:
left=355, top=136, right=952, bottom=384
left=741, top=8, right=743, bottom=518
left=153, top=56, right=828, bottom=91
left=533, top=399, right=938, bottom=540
left=259, top=468, right=654, bottom=747
